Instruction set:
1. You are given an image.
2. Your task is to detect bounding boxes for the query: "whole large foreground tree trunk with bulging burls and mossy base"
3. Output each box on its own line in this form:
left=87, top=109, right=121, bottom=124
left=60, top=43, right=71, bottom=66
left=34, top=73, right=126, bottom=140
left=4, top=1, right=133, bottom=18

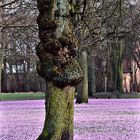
left=36, top=0, right=82, bottom=140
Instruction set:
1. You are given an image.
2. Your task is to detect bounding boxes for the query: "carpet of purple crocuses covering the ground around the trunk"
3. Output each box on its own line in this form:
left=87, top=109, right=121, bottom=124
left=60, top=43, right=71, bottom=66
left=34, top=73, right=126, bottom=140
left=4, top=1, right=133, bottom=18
left=0, top=99, right=140, bottom=140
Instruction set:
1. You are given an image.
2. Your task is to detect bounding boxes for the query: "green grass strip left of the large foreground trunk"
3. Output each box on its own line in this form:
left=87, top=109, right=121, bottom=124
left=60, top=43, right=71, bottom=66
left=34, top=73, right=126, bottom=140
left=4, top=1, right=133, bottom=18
left=0, top=92, right=45, bottom=101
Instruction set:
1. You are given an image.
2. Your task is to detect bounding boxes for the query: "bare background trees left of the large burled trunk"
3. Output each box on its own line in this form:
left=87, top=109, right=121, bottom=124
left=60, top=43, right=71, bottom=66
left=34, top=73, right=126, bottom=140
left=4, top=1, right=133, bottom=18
left=0, top=0, right=45, bottom=92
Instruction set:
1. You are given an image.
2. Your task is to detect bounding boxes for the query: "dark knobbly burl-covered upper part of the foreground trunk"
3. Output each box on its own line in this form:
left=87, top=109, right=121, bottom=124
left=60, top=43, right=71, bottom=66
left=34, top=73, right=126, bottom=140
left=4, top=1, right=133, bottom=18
left=36, top=0, right=82, bottom=87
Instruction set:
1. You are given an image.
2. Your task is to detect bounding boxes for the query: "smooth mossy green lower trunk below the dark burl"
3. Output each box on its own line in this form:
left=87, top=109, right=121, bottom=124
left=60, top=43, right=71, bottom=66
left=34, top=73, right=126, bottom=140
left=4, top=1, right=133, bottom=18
left=37, top=83, right=75, bottom=140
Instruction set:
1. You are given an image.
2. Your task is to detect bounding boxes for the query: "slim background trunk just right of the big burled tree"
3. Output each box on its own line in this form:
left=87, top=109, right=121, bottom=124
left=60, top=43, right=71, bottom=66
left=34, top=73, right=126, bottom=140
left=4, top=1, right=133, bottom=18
left=76, top=51, right=88, bottom=103
